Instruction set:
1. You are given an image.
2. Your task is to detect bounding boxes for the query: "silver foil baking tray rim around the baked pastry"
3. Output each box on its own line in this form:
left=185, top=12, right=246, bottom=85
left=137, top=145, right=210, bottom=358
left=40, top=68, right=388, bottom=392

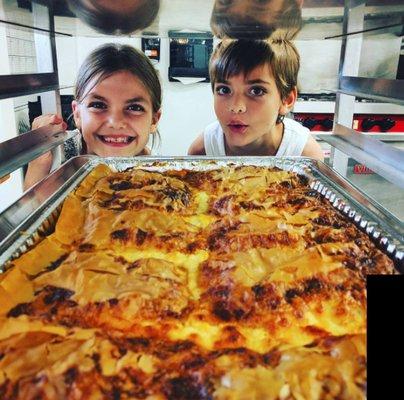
left=0, top=156, right=404, bottom=273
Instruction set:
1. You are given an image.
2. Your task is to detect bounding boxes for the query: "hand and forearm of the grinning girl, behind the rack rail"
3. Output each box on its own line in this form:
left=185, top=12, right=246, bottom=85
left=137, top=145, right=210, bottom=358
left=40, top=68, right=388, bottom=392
left=24, top=114, right=67, bottom=190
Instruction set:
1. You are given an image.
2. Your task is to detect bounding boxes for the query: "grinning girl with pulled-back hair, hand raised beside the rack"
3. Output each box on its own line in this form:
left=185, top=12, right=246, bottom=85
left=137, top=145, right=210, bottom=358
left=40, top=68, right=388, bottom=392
left=24, top=44, right=162, bottom=189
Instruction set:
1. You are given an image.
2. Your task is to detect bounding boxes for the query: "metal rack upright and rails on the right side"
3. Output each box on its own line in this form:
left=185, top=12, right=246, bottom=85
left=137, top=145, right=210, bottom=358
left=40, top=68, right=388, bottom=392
left=322, top=0, right=404, bottom=188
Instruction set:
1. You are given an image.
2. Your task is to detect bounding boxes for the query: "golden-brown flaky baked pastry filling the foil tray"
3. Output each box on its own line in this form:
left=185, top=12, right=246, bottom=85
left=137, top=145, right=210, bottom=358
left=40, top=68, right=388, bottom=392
left=0, top=165, right=394, bottom=400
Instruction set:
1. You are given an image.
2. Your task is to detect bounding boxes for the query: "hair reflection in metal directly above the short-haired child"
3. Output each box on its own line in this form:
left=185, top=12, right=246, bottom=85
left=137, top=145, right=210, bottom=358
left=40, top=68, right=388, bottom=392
left=210, top=0, right=302, bottom=40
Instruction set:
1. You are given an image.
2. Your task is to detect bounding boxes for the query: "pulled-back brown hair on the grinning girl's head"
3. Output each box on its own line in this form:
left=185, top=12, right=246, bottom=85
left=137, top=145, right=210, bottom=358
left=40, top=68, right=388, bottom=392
left=74, top=43, right=162, bottom=146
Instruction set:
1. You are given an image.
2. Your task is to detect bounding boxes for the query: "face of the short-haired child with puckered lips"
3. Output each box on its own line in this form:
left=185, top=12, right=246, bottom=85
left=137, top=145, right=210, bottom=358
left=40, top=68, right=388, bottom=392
left=214, top=64, right=296, bottom=147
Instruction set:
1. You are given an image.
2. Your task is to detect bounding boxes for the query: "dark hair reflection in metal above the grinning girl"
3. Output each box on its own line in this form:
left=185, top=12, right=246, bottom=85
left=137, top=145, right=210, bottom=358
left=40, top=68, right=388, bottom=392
left=67, top=0, right=160, bottom=34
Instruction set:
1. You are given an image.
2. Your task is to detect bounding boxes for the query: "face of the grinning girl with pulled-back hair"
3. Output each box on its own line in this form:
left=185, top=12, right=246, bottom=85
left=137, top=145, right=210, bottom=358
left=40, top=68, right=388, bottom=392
left=72, top=71, right=160, bottom=157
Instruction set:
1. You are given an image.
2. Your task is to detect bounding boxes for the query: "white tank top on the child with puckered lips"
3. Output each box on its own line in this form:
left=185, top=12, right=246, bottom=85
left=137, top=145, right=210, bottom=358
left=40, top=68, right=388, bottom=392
left=203, top=118, right=310, bottom=157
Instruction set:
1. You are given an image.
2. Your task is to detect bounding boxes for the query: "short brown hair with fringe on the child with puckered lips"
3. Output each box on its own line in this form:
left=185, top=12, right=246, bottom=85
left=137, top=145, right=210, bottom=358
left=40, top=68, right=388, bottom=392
left=209, top=39, right=300, bottom=99
